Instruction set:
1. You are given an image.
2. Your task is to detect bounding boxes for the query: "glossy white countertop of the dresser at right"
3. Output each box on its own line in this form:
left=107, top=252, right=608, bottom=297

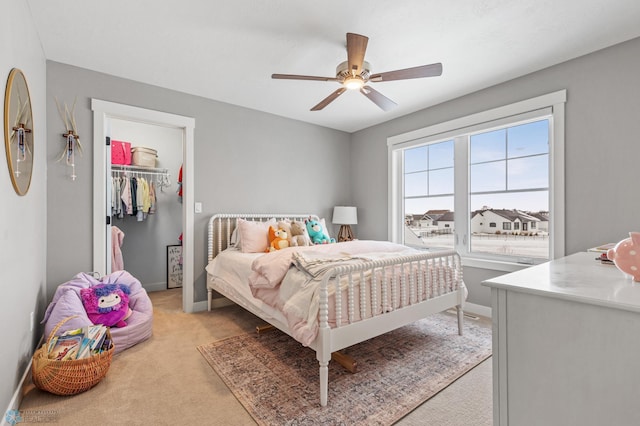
left=482, top=252, right=640, bottom=312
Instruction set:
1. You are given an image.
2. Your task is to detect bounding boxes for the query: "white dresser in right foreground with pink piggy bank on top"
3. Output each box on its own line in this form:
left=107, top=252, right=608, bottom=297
left=483, top=253, right=640, bottom=426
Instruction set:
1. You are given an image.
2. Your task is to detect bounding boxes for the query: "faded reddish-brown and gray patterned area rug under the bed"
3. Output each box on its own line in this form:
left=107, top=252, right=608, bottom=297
left=198, top=313, right=491, bottom=425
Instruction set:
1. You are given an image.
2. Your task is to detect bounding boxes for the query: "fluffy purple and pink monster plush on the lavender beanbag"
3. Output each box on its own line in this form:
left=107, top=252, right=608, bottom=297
left=80, top=284, right=132, bottom=327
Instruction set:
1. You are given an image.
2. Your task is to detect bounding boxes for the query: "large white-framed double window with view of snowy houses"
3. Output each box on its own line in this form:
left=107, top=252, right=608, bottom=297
left=388, top=91, right=566, bottom=266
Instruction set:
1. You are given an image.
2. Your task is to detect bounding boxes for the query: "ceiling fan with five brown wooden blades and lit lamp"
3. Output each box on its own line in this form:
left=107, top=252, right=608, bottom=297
left=271, top=33, right=442, bottom=111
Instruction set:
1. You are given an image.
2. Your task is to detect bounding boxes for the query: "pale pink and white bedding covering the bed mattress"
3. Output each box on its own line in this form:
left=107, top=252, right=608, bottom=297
left=207, top=241, right=456, bottom=346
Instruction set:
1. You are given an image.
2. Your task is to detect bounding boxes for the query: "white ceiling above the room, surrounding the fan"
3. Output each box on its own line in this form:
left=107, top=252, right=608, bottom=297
left=27, top=0, right=640, bottom=132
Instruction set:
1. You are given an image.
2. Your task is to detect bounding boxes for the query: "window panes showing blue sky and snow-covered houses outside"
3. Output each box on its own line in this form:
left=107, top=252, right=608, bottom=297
left=403, top=118, right=550, bottom=259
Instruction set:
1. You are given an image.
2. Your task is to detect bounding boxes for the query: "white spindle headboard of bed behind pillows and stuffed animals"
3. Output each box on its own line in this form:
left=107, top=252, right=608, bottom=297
left=207, top=213, right=320, bottom=263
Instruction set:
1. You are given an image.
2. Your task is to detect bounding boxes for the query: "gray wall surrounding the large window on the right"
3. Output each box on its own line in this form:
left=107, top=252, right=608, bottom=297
left=351, top=38, right=640, bottom=306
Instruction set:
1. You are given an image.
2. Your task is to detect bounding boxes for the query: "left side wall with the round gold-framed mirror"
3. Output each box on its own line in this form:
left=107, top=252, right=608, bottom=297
left=0, top=0, right=47, bottom=416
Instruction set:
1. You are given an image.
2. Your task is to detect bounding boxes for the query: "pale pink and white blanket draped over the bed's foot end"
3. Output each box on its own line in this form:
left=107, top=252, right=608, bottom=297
left=249, top=240, right=418, bottom=346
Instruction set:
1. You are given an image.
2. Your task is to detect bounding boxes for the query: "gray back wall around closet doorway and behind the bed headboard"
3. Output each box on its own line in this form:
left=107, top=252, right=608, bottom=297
left=47, top=61, right=351, bottom=301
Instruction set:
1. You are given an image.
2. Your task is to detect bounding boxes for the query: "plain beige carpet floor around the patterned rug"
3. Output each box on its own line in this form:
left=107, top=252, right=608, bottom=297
left=20, top=289, right=492, bottom=426
